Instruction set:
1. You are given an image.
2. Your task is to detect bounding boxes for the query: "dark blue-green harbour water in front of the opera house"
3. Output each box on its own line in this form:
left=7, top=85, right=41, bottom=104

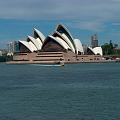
left=0, top=63, right=120, bottom=120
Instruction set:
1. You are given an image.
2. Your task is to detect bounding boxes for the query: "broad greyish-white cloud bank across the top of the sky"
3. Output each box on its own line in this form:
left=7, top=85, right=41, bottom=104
left=0, top=0, right=120, bottom=34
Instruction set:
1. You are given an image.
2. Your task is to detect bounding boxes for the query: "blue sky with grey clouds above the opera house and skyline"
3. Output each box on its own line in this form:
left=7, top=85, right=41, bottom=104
left=0, top=0, right=120, bottom=48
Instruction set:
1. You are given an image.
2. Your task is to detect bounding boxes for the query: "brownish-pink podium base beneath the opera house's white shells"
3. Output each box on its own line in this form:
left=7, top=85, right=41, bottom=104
left=7, top=51, right=103, bottom=64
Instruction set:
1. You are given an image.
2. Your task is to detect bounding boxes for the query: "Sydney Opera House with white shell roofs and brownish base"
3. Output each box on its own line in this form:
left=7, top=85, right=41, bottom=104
left=8, top=24, right=102, bottom=63
